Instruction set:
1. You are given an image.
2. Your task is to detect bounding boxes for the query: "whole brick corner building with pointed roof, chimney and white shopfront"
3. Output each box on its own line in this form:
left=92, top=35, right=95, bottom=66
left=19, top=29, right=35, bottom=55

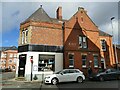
left=16, top=7, right=115, bottom=80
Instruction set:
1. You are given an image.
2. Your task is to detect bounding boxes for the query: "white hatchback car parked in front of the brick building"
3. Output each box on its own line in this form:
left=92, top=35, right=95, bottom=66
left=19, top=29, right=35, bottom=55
left=44, top=69, right=85, bottom=85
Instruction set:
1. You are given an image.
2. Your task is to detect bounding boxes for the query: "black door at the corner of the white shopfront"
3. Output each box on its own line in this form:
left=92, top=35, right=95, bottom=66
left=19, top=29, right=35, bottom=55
left=18, top=54, right=27, bottom=77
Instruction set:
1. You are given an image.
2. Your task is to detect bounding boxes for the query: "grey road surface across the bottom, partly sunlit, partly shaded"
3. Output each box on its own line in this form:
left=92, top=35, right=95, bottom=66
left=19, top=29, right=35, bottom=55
left=0, top=73, right=120, bottom=90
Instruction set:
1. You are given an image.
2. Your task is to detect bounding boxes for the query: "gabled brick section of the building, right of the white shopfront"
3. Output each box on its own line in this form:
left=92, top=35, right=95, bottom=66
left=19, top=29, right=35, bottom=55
left=64, top=7, right=115, bottom=74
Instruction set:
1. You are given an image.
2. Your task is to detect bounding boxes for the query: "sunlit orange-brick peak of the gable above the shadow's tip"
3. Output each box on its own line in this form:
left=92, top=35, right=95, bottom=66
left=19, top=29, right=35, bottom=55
left=65, top=8, right=98, bottom=31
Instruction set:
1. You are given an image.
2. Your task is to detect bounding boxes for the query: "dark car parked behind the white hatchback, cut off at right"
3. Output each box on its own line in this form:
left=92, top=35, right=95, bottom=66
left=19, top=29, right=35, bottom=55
left=89, top=68, right=120, bottom=81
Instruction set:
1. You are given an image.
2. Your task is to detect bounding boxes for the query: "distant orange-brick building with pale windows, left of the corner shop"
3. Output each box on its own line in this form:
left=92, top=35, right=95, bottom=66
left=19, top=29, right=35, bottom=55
left=0, top=46, right=18, bottom=71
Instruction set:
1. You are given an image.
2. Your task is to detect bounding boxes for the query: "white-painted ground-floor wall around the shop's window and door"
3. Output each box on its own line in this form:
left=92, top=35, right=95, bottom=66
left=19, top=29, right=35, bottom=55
left=16, top=52, right=63, bottom=81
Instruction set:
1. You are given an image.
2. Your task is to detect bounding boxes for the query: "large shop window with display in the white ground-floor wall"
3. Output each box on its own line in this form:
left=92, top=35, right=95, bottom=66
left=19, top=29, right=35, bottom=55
left=38, top=54, right=55, bottom=71
